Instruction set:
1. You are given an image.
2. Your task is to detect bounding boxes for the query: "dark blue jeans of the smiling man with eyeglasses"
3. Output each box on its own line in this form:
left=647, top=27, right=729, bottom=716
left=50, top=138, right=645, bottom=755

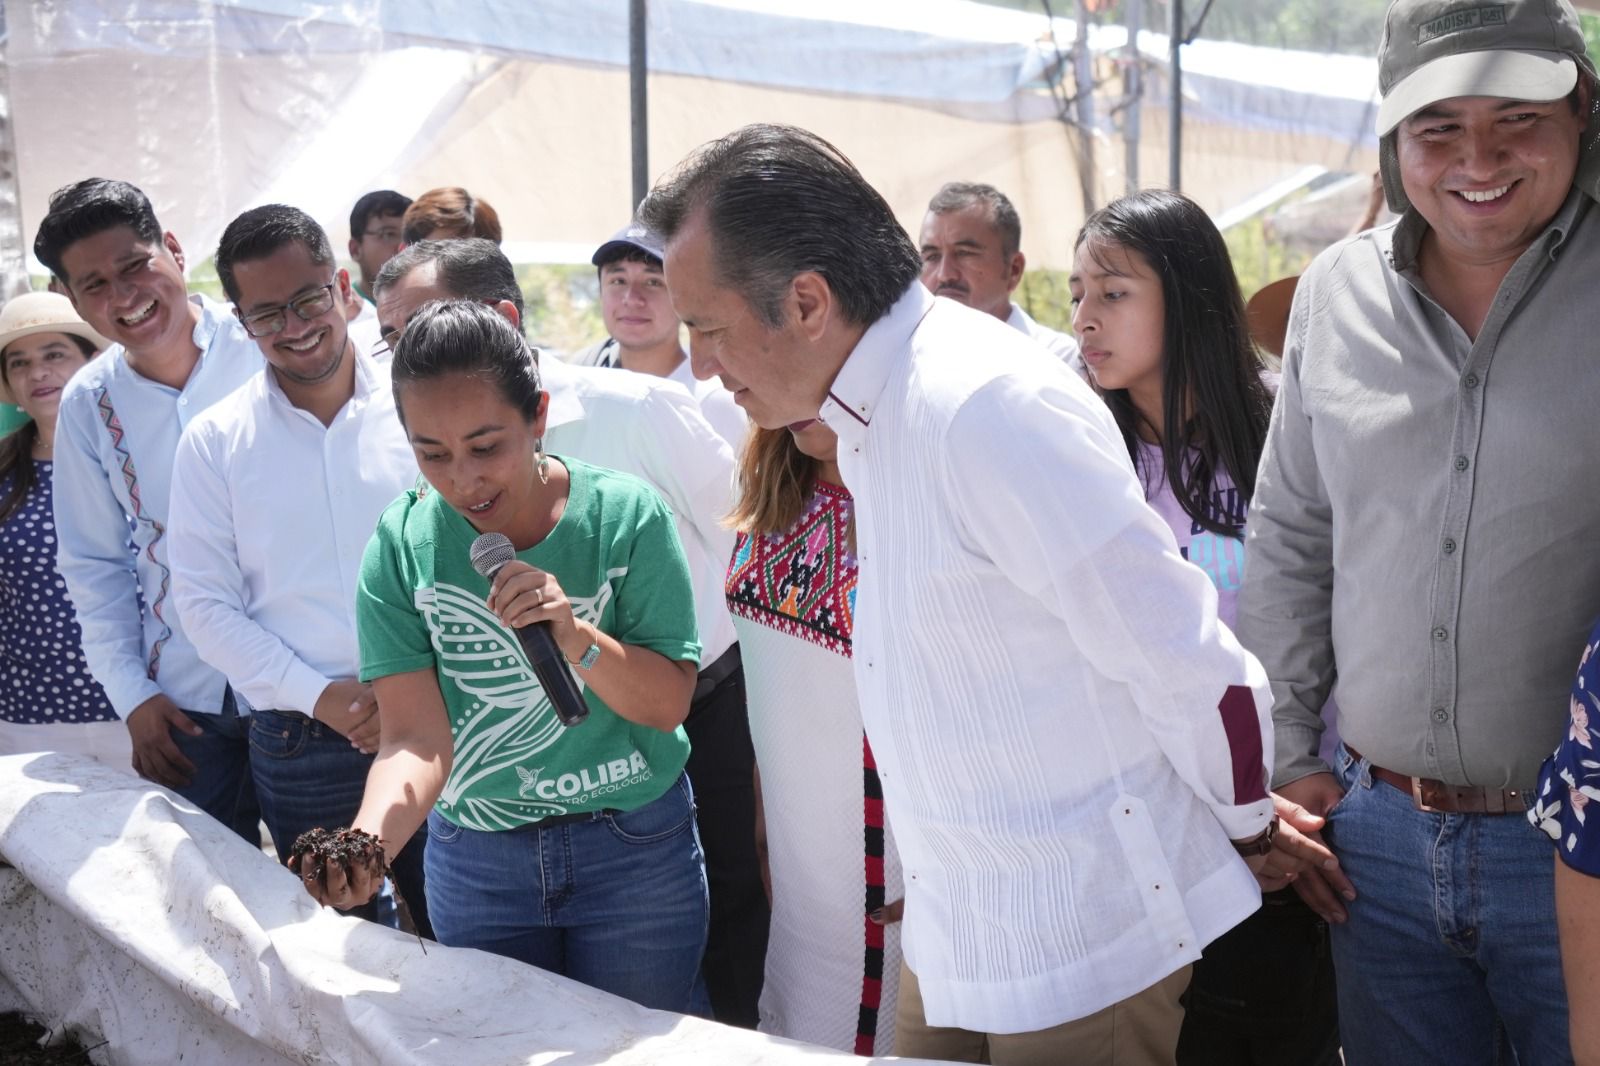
left=250, top=711, right=434, bottom=936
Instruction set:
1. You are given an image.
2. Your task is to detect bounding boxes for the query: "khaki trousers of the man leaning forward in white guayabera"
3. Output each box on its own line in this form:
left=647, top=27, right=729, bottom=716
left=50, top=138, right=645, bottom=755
left=894, top=962, right=1194, bottom=1066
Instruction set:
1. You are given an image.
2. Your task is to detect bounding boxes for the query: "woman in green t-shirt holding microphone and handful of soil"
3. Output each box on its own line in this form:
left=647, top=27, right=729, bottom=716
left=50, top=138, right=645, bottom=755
left=299, top=301, right=707, bottom=1010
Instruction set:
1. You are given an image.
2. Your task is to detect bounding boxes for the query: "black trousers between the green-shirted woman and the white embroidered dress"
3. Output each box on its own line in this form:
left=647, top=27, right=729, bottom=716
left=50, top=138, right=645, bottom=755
left=683, top=645, right=771, bottom=1029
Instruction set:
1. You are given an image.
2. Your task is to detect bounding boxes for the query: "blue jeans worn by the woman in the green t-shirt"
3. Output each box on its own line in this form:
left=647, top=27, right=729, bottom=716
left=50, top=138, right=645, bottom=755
left=427, top=775, right=709, bottom=1012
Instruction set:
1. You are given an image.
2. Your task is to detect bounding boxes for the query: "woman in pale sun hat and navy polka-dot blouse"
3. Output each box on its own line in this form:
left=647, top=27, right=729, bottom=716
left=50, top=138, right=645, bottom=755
left=0, top=293, right=123, bottom=770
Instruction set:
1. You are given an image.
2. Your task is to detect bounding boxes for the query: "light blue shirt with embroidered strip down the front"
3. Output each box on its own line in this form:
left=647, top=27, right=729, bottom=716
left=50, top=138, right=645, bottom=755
left=54, top=295, right=261, bottom=717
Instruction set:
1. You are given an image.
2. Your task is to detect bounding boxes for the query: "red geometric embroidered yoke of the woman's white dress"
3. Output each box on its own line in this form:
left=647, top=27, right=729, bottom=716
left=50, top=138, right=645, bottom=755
left=725, top=482, right=856, bottom=656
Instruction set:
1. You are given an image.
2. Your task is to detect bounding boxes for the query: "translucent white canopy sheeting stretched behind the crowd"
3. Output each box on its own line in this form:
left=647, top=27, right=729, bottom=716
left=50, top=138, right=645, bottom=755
left=0, top=0, right=1376, bottom=285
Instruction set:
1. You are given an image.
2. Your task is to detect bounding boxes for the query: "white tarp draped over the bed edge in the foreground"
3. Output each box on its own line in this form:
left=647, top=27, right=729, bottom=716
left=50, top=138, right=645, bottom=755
left=0, top=754, right=918, bottom=1066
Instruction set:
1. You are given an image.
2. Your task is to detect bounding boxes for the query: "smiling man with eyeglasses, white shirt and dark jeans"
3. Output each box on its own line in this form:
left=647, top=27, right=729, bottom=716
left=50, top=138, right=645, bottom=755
left=170, top=203, right=429, bottom=933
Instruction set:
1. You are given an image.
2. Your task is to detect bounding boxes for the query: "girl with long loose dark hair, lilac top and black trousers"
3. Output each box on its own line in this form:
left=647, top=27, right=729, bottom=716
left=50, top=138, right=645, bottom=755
left=1070, top=190, right=1339, bottom=1066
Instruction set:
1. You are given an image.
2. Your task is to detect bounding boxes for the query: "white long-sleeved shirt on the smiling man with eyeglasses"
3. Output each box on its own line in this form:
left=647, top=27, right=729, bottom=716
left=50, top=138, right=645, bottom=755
left=168, top=354, right=418, bottom=715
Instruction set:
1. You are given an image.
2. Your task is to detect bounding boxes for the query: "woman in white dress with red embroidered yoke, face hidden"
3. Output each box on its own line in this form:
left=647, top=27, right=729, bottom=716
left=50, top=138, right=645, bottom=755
left=728, top=421, right=904, bottom=1055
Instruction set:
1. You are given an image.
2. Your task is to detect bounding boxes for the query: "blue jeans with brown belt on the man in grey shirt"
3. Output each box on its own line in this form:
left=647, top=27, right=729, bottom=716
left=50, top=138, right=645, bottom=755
left=1326, top=744, right=1573, bottom=1066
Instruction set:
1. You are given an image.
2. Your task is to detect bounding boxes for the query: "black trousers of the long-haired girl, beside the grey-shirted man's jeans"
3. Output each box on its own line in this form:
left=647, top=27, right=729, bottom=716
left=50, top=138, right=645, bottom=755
left=1178, top=888, right=1341, bottom=1066
